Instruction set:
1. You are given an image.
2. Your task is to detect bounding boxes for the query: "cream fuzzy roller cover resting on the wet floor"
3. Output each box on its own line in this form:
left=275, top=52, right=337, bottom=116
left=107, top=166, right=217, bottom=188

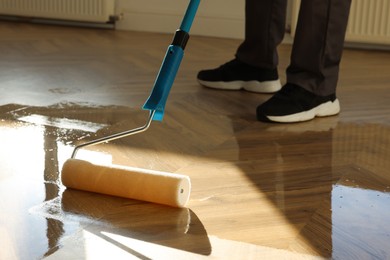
left=61, top=159, right=191, bottom=207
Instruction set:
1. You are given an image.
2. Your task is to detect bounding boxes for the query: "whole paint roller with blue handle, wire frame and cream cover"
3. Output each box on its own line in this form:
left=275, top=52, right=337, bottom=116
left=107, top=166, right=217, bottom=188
left=61, top=0, right=200, bottom=207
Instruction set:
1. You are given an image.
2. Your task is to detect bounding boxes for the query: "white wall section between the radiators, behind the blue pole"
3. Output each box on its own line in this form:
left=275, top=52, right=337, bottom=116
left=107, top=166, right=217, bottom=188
left=116, top=0, right=245, bottom=39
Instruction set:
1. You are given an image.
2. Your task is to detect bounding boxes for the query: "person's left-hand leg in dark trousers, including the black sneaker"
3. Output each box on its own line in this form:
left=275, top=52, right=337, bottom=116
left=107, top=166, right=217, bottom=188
left=197, top=0, right=287, bottom=93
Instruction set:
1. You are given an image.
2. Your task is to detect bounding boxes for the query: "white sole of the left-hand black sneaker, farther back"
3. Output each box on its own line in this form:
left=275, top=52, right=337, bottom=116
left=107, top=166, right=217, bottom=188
left=198, top=79, right=282, bottom=93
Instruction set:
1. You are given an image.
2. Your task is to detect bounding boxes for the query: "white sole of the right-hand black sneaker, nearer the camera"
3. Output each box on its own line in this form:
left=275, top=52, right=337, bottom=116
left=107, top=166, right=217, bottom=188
left=267, top=99, right=340, bottom=123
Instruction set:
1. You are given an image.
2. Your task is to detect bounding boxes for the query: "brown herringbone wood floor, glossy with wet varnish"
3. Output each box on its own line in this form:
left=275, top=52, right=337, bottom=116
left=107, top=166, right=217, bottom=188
left=0, top=22, right=390, bottom=259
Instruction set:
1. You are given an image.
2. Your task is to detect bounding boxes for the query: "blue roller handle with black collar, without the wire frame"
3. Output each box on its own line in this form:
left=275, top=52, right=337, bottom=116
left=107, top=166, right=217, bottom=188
left=142, top=0, right=200, bottom=121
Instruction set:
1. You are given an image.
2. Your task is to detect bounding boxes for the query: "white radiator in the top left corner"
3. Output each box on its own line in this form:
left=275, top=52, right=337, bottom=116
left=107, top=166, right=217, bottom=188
left=0, top=0, right=115, bottom=23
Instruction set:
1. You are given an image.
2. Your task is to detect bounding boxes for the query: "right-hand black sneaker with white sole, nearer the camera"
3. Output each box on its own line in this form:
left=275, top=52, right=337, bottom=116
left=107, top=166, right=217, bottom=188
left=256, top=83, right=340, bottom=123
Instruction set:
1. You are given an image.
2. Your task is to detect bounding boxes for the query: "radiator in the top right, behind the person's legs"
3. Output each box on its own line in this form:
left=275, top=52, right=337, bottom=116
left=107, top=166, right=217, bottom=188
left=291, top=0, right=390, bottom=45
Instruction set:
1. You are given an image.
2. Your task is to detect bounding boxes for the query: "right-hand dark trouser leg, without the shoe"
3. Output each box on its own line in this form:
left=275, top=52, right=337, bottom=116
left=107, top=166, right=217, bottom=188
left=286, top=0, right=351, bottom=96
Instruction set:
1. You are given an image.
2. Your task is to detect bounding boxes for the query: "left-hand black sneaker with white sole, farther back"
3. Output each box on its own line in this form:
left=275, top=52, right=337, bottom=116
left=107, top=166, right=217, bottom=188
left=198, top=59, right=281, bottom=93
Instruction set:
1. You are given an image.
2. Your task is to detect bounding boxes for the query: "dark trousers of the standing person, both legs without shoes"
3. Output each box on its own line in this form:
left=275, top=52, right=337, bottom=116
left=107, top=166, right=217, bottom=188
left=236, top=0, right=351, bottom=96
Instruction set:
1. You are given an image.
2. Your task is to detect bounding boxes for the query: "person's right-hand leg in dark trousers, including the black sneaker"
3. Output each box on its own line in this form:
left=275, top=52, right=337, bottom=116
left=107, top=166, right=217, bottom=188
left=256, top=0, right=351, bottom=122
